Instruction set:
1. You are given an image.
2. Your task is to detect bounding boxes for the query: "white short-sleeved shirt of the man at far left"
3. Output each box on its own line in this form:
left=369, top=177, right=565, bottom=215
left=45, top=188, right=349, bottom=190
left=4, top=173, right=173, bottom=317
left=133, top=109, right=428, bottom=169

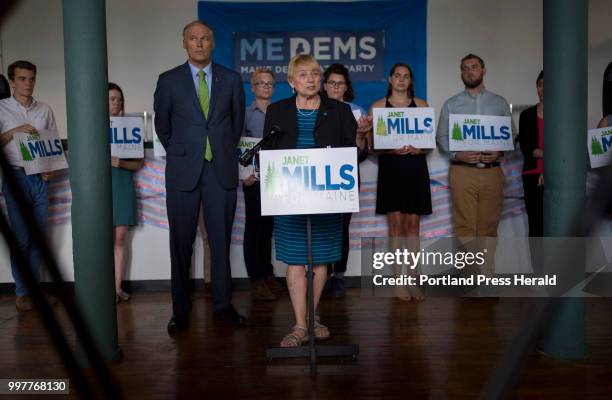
left=0, top=97, right=57, bottom=167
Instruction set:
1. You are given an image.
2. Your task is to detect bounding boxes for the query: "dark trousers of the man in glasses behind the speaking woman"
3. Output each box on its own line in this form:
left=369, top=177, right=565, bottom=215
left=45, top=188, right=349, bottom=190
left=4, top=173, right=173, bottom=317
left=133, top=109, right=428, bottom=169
left=242, top=182, right=274, bottom=281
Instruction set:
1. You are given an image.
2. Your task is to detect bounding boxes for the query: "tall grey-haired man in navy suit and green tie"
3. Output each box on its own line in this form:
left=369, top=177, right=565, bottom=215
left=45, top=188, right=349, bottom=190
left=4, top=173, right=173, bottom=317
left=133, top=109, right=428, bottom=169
left=154, top=21, right=245, bottom=334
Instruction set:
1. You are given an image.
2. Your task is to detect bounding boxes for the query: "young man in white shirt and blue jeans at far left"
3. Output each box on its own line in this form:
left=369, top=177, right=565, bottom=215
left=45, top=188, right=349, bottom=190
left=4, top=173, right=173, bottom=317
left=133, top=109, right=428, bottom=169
left=0, top=61, right=57, bottom=311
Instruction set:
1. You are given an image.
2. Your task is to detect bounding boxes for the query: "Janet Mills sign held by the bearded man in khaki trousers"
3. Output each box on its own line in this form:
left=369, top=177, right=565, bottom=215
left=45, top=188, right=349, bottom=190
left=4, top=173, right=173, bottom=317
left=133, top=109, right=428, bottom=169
left=448, top=114, right=514, bottom=151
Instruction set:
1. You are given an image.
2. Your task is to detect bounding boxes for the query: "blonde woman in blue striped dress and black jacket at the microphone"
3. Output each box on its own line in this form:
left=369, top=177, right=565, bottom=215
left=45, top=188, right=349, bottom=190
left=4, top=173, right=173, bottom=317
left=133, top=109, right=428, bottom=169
left=264, top=54, right=357, bottom=347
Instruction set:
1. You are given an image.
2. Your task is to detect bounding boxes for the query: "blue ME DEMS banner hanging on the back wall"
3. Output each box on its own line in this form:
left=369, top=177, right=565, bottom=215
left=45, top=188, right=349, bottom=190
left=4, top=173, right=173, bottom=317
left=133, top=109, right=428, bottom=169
left=198, top=0, right=427, bottom=109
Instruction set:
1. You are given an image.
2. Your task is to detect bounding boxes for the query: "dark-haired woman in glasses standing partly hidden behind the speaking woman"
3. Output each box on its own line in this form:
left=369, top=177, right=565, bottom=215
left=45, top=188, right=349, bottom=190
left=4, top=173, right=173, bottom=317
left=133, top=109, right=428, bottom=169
left=323, top=63, right=372, bottom=297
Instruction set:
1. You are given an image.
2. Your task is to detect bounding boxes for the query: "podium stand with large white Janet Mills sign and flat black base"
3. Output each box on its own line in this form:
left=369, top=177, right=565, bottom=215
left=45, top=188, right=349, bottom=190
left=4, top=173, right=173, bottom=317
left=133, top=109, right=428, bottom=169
left=259, top=147, right=359, bottom=377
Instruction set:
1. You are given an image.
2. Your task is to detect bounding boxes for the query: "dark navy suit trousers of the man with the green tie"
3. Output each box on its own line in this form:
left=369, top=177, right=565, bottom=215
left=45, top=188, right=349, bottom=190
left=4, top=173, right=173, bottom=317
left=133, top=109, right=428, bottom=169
left=166, top=162, right=236, bottom=318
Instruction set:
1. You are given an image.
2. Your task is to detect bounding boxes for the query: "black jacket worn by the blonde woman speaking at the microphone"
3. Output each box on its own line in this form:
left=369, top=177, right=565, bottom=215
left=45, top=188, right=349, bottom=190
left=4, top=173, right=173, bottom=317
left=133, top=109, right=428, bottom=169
left=264, top=95, right=357, bottom=149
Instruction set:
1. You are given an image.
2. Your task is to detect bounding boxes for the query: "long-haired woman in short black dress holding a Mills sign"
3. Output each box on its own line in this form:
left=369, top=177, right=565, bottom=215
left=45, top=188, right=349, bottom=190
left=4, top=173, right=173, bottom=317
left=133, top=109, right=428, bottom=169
left=370, top=63, right=431, bottom=301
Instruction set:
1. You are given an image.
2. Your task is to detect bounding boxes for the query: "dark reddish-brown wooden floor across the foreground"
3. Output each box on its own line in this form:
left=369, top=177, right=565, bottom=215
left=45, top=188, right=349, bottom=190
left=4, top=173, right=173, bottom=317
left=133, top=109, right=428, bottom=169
left=0, top=289, right=612, bottom=400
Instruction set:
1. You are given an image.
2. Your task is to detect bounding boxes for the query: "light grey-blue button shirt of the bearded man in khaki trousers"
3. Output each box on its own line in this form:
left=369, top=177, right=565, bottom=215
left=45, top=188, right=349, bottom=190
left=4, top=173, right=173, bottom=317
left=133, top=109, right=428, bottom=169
left=436, top=89, right=516, bottom=159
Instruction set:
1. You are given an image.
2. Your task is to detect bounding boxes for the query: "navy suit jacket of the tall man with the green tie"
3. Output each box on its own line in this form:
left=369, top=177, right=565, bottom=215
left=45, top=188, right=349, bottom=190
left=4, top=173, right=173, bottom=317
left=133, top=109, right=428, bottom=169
left=153, top=63, right=244, bottom=191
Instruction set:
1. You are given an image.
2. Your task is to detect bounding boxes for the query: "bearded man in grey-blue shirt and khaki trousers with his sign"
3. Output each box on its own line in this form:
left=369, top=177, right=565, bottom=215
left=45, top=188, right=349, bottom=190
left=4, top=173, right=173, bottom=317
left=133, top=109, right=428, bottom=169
left=436, top=54, right=513, bottom=278
